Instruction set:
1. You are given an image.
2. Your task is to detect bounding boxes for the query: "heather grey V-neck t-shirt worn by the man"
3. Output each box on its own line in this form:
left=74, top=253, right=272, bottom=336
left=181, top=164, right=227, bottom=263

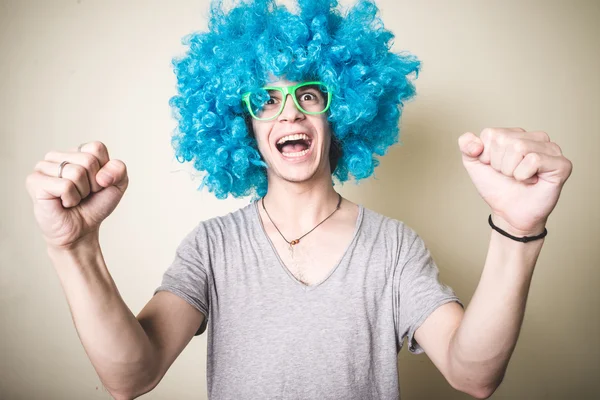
left=156, top=201, right=462, bottom=400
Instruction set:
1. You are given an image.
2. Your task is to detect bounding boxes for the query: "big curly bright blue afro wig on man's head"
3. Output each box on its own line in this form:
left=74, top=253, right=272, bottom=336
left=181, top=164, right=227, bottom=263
left=169, top=0, right=420, bottom=199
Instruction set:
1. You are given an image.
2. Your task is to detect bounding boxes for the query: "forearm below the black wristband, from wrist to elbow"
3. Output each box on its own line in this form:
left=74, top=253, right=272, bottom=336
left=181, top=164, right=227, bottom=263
left=449, top=222, right=543, bottom=394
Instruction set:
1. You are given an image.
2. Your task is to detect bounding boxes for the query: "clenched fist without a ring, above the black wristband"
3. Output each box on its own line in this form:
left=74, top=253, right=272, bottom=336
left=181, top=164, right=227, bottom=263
left=458, top=128, right=573, bottom=236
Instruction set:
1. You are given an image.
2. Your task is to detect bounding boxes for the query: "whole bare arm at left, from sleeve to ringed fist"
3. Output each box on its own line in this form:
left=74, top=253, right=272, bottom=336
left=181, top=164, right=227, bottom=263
left=25, top=141, right=204, bottom=399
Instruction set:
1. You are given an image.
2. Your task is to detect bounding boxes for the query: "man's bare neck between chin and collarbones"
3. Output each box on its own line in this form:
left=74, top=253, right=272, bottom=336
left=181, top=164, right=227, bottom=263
left=260, top=177, right=339, bottom=233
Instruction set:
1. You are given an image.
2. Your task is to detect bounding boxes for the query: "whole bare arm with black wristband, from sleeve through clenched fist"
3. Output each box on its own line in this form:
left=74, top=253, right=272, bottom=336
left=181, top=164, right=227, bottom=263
left=415, top=128, right=573, bottom=398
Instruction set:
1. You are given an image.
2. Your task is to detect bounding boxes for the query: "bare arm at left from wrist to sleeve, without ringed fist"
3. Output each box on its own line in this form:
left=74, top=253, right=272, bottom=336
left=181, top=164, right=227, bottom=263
left=48, top=236, right=204, bottom=399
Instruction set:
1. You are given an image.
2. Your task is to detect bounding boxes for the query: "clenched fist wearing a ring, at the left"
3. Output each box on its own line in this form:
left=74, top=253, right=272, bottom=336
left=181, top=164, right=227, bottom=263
left=25, top=142, right=129, bottom=249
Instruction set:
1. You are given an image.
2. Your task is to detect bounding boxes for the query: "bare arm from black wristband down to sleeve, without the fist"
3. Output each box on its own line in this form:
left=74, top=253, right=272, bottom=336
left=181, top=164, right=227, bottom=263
left=415, top=218, right=543, bottom=398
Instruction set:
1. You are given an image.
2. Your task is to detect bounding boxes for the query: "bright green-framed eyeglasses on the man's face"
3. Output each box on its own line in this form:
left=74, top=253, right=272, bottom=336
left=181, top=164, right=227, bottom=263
left=242, top=82, right=331, bottom=121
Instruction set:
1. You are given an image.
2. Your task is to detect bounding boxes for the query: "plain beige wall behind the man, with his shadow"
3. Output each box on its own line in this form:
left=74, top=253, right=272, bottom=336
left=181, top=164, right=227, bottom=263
left=0, top=0, right=600, bottom=400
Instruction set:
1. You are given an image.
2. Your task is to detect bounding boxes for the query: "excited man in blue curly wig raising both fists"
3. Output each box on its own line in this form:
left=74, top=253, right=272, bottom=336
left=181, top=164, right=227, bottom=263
left=27, top=1, right=572, bottom=399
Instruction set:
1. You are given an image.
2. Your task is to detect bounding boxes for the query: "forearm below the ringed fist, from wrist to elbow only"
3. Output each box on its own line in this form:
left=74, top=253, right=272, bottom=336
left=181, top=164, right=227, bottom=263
left=48, top=236, right=156, bottom=398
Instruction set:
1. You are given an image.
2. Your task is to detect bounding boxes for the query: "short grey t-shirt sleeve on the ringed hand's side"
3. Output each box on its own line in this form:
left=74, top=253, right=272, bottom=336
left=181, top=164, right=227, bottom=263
left=154, top=224, right=210, bottom=336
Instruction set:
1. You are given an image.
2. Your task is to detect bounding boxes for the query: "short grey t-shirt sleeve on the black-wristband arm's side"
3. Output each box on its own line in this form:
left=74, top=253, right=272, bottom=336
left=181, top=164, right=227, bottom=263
left=394, top=227, right=464, bottom=354
